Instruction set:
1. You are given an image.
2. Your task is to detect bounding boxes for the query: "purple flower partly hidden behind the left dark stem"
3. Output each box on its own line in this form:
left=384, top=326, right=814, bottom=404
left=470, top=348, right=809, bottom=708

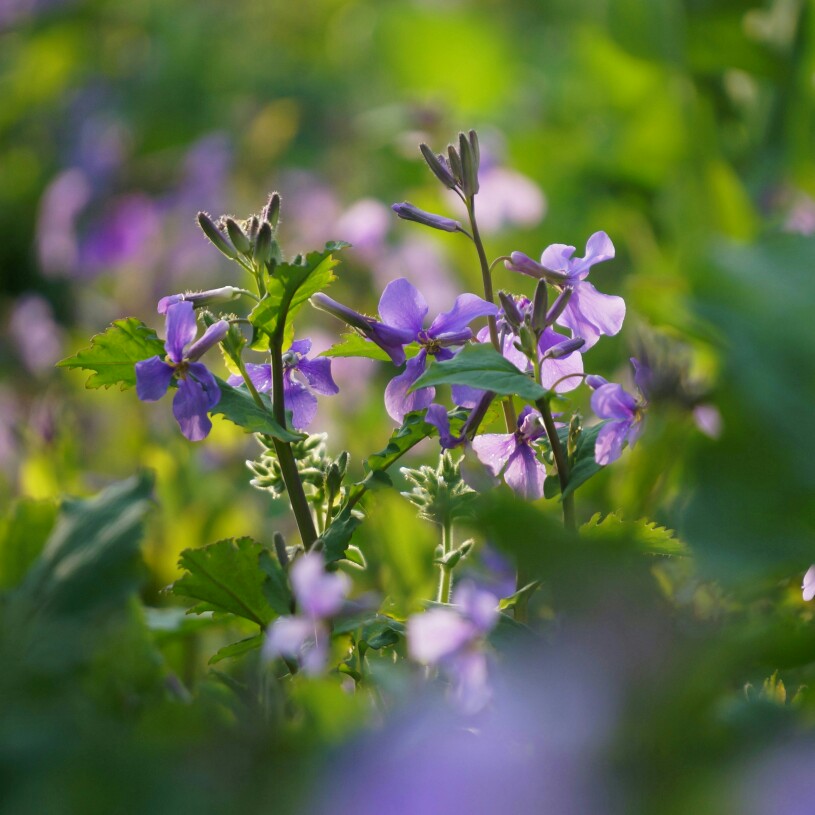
left=227, top=340, right=340, bottom=430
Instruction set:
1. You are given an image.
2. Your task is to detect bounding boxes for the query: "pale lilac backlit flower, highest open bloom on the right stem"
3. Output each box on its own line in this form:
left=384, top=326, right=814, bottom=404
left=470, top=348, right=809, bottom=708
left=506, top=232, right=625, bottom=349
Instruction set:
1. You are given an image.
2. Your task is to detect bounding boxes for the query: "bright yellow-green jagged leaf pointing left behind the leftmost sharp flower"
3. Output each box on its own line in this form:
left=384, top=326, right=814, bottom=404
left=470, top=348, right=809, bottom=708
left=57, top=317, right=165, bottom=390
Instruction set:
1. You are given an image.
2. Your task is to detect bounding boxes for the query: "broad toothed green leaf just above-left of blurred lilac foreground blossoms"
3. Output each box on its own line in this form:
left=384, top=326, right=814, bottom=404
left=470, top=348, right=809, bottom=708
left=172, top=538, right=284, bottom=628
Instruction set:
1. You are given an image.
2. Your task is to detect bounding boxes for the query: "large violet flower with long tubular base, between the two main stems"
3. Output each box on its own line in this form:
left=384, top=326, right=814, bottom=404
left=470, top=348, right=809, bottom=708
left=311, top=277, right=498, bottom=422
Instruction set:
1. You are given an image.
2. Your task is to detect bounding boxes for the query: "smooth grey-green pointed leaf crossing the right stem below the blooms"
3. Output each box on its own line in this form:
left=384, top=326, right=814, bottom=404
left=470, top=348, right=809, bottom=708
left=410, top=343, right=547, bottom=402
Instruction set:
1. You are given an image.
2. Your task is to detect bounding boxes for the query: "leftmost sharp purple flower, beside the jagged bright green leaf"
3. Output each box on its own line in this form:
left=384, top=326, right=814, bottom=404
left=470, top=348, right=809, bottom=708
left=136, top=301, right=229, bottom=441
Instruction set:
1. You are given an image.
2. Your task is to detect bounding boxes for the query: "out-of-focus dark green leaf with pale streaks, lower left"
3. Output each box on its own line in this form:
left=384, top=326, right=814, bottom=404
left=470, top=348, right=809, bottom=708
left=18, top=474, right=153, bottom=615
